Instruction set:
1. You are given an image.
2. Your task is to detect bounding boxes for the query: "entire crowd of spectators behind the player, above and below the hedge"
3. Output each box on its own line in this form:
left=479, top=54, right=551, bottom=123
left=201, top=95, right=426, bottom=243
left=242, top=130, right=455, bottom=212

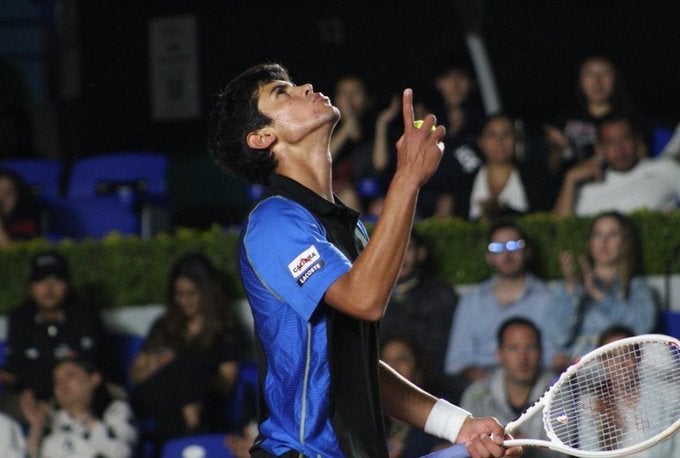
left=0, top=52, right=680, bottom=458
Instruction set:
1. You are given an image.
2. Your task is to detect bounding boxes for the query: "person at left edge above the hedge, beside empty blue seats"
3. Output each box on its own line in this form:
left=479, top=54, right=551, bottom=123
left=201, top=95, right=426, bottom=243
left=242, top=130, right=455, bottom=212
left=0, top=170, right=40, bottom=248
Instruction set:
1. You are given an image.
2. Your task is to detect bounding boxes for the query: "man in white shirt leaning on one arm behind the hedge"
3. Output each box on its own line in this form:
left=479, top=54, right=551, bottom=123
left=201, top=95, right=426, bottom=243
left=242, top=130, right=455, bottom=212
left=554, top=116, right=680, bottom=216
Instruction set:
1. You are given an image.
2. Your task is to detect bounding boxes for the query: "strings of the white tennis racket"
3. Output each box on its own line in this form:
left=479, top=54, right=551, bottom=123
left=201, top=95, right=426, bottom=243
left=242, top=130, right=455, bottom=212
left=544, top=342, right=680, bottom=451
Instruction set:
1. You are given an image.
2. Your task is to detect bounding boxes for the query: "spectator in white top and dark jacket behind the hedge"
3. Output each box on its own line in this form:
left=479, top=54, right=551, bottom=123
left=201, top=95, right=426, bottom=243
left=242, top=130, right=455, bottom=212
left=469, top=114, right=548, bottom=220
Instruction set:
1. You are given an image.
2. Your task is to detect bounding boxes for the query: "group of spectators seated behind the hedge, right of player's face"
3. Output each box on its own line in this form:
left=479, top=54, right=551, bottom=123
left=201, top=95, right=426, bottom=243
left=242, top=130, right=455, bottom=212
left=331, top=55, right=680, bottom=221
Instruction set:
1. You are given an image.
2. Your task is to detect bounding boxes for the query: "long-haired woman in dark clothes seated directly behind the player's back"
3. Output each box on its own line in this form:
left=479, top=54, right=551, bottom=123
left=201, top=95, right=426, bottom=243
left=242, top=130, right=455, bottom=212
left=130, top=254, right=251, bottom=445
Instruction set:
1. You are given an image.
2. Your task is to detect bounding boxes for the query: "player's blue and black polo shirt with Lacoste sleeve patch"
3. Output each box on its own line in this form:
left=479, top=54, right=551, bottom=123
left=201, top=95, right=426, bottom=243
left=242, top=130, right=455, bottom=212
left=239, top=175, right=387, bottom=458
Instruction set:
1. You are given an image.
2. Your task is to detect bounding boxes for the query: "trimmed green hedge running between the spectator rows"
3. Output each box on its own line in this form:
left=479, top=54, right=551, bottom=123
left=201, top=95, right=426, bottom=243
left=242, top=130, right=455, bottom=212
left=0, top=211, right=680, bottom=313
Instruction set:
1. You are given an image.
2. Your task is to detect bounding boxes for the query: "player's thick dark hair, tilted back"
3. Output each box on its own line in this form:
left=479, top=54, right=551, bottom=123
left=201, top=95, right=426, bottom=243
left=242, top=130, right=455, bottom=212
left=207, top=63, right=291, bottom=185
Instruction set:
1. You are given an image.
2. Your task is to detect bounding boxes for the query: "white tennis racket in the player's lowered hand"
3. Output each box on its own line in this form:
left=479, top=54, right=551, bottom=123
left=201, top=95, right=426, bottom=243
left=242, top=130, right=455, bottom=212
left=504, top=334, right=680, bottom=458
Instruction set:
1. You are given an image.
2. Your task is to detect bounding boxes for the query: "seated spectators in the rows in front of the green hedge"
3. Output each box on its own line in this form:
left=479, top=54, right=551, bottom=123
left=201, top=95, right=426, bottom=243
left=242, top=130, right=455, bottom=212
left=0, top=211, right=669, bottom=458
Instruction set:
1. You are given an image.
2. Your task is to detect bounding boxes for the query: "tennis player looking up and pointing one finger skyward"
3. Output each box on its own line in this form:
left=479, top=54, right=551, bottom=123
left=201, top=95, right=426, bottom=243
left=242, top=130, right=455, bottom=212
left=209, top=64, right=521, bottom=458
